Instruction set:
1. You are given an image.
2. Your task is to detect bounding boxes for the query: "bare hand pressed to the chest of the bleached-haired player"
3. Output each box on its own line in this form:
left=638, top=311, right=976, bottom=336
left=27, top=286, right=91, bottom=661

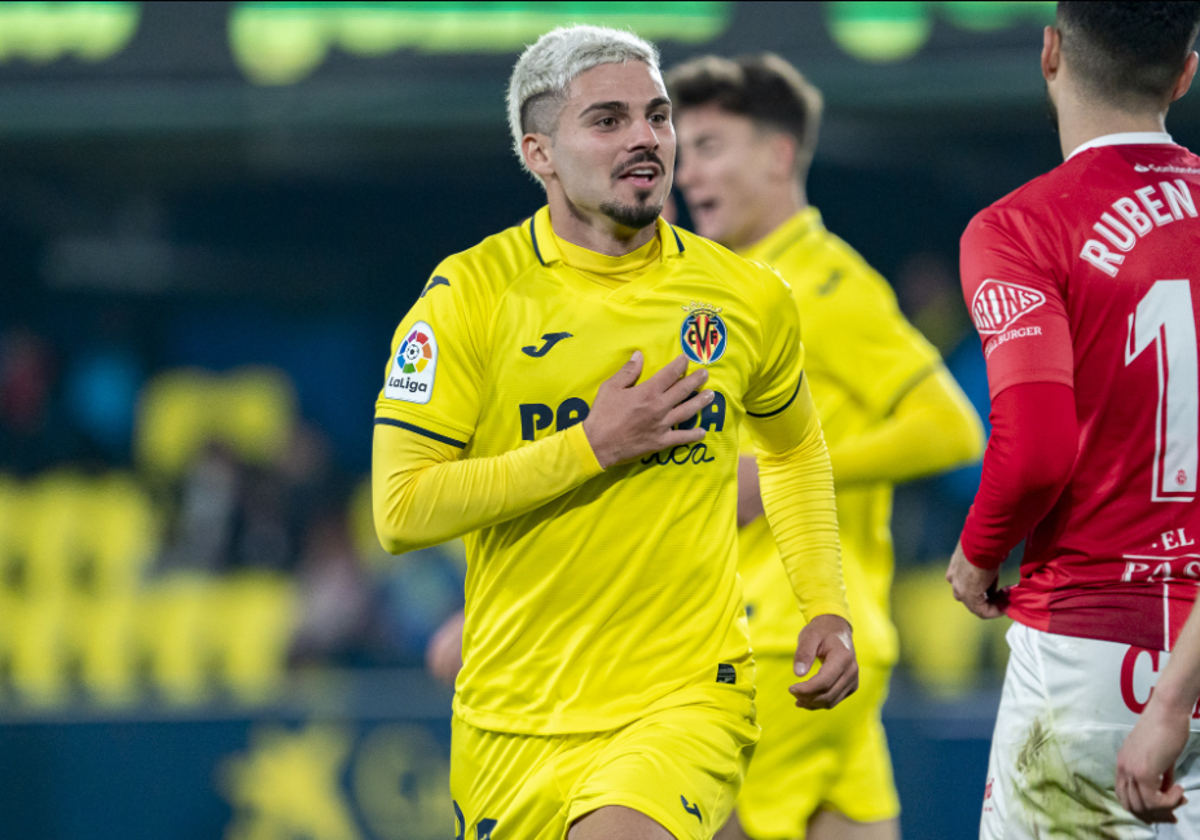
left=583, top=350, right=713, bottom=469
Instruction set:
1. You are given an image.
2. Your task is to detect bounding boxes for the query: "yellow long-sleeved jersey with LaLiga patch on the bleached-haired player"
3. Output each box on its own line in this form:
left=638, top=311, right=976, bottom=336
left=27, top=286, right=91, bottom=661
left=373, top=209, right=847, bottom=734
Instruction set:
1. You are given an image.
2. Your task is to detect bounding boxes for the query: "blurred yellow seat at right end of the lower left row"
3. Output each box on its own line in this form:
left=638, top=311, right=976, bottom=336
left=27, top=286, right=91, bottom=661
left=210, top=572, right=299, bottom=703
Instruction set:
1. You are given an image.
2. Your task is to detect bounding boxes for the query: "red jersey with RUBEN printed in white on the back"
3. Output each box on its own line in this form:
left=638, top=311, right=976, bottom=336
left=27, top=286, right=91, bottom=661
left=962, top=133, right=1200, bottom=650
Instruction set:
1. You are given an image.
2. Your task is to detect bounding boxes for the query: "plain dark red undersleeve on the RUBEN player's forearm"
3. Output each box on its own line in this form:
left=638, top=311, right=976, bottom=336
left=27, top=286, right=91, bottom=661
left=962, top=382, right=1079, bottom=569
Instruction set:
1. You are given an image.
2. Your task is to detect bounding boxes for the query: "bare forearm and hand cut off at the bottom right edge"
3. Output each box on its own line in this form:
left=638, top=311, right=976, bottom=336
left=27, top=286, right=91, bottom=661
left=1116, top=600, right=1200, bottom=822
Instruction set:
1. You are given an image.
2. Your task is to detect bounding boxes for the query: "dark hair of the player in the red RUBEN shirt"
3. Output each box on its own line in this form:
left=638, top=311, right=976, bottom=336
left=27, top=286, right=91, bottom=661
left=1058, top=0, right=1200, bottom=110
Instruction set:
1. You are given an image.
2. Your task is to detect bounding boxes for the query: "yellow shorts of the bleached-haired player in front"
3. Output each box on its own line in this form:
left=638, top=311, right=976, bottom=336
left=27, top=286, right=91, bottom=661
left=450, top=674, right=758, bottom=840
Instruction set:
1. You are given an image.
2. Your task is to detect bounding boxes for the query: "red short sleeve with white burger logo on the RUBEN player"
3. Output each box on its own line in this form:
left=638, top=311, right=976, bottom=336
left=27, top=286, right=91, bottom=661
left=960, top=210, right=1075, bottom=400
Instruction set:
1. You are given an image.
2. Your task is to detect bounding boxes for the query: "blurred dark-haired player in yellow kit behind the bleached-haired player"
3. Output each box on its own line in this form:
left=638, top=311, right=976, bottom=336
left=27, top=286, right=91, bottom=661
left=667, top=55, right=983, bottom=840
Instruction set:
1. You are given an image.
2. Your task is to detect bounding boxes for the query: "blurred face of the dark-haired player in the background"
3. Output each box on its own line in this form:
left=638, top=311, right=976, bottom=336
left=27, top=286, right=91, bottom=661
left=676, top=104, right=778, bottom=248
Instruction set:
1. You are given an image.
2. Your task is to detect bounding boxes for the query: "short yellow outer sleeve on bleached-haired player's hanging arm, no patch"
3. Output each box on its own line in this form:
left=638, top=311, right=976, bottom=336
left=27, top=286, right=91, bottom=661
left=745, top=263, right=804, bottom=418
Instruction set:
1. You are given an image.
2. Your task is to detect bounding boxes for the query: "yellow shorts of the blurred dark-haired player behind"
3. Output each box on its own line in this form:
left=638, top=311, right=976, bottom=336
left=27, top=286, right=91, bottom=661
left=738, top=654, right=900, bottom=840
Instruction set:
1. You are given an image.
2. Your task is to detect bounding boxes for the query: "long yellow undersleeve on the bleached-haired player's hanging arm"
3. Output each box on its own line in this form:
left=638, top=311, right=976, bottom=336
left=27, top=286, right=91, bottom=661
left=750, top=386, right=850, bottom=620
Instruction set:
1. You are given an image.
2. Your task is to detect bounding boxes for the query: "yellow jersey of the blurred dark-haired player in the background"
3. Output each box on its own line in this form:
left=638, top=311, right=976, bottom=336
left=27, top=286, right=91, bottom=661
left=739, top=208, right=982, bottom=665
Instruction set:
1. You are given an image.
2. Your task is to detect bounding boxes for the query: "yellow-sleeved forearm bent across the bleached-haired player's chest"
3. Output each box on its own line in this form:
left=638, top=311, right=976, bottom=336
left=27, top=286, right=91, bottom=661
left=372, top=425, right=602, bottom=554
